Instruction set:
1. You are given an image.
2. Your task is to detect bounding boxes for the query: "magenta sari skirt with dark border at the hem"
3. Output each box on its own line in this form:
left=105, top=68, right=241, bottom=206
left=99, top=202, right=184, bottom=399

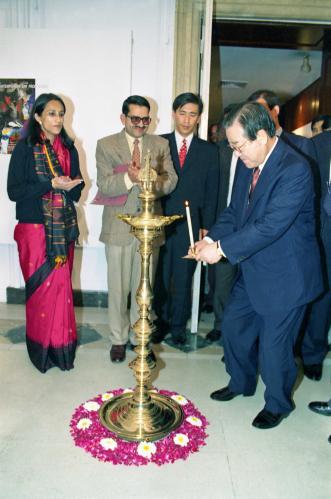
left=14, top=223, right=77, bottom=373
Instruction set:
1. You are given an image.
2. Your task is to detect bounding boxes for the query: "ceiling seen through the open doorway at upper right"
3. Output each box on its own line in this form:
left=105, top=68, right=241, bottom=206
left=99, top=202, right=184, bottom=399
left=212, top=20, right=330, bottom=109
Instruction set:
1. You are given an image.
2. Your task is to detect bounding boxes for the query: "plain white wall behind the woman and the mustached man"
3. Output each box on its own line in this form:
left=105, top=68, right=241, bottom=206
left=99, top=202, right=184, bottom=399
left=0, top=0, right=175, bottom=301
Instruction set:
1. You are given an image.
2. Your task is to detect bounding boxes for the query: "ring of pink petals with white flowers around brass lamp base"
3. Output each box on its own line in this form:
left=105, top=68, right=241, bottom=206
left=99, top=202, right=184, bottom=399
left=70, top=388, right=209, bottom=466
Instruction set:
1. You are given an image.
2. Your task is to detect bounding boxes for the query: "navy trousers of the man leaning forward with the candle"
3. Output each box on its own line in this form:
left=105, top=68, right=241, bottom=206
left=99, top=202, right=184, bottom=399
left=221, top=278, right=306, bottom=414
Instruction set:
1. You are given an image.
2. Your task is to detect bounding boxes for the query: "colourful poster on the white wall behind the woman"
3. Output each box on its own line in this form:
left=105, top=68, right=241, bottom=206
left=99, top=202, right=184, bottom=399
left=0, top=78, right=36, bottom=154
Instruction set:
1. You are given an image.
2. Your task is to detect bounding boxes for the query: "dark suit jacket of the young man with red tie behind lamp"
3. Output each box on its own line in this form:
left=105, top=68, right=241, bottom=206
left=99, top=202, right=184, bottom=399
left=161, top=132, right=219, bottom=242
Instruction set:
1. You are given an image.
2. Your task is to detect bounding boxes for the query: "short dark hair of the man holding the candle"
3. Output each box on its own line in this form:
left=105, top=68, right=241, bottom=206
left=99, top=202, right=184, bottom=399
left=223, top=102, right=276, bottom=140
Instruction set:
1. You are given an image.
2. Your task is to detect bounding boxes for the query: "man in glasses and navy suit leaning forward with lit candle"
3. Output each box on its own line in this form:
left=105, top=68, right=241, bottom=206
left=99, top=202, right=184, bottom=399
left=195, top=102, right=322, bottom=429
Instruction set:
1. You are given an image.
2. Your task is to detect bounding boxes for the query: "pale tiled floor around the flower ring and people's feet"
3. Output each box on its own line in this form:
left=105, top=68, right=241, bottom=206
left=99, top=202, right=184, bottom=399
left=0, top=304, right=331, bottom=499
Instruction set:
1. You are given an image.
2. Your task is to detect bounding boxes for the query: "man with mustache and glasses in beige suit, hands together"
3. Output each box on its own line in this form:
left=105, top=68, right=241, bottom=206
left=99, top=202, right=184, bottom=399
left=96, top=95, right=177, bottom=362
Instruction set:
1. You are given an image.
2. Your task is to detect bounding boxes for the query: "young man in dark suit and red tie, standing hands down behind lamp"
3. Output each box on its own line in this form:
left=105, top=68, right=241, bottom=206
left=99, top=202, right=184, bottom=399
left=152, top=92, right=219, bottom=345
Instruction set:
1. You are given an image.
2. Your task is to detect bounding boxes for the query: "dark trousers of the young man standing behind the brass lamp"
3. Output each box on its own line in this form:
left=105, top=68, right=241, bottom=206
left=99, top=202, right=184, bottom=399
left=154, top=233, right=196, bottom=337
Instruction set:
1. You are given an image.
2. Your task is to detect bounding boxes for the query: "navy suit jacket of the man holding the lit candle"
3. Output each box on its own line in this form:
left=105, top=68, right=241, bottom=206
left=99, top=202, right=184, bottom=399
left=208, top=140, right=322, bottom=314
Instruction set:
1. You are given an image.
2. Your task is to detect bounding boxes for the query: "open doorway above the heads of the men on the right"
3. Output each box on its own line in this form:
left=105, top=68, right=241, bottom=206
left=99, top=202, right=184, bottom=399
left=209, top=19, right=331, bottom=137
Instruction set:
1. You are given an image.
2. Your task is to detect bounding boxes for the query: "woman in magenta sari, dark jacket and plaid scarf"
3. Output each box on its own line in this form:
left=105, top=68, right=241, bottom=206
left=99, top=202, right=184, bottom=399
left=7, top=94, right=84, bottom=373
